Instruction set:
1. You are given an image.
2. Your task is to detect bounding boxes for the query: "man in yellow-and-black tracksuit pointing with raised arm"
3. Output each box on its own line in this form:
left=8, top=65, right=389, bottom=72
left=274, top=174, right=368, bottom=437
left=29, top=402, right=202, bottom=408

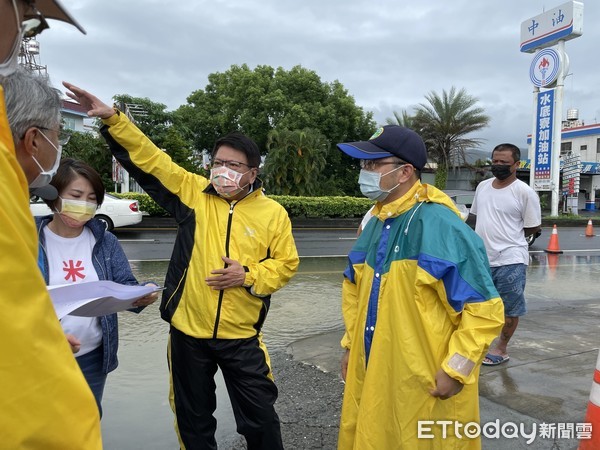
left=63, top=83, right=299, bottom=450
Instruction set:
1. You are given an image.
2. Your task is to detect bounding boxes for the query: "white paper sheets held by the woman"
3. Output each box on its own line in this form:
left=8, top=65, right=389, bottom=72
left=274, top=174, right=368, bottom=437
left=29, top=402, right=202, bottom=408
left=48, top=280, right=161, bottom=319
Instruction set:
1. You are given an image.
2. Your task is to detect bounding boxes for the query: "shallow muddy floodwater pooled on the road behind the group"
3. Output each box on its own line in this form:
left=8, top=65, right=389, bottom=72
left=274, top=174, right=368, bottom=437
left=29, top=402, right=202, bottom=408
left=102, top=254, right=600, bottom=450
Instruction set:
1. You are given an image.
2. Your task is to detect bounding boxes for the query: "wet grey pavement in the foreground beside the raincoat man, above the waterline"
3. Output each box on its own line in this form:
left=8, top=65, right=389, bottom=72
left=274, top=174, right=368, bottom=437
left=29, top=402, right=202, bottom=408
left=224, top=300, right=600, bottom=450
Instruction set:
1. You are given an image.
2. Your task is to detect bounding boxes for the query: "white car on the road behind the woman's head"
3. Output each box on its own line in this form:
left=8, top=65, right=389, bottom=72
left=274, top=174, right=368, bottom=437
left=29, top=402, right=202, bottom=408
left=29, top=194, right=142, bottom=231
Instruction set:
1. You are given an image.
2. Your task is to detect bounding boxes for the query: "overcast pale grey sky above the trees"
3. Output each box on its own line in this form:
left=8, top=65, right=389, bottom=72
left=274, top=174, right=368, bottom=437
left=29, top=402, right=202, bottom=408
left=39, top=0, right=600, bottom=155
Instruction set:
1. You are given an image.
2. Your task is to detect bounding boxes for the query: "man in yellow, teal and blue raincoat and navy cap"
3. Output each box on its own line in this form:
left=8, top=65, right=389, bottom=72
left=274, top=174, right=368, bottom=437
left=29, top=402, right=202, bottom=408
left=338, top=125, right=504, bottom=450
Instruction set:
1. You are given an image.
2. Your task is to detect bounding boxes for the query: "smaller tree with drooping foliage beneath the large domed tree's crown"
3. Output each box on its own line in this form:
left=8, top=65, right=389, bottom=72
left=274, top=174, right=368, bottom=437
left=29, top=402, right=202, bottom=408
left=263, top=128, right=329, bottom=196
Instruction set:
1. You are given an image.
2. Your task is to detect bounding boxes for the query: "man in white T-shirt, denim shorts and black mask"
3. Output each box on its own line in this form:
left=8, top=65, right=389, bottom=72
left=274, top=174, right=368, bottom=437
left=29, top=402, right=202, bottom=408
left=470, top=144, right=542, bottom=366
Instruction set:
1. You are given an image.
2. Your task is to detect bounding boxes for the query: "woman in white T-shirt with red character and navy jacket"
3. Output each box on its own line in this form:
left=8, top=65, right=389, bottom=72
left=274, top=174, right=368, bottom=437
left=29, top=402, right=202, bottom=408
left=36, top=158, right=158, bottom=415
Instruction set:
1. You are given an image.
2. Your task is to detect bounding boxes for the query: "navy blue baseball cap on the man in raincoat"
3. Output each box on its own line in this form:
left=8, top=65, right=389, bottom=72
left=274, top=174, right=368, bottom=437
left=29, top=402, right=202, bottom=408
left=337, top=125, right=427, bottom=170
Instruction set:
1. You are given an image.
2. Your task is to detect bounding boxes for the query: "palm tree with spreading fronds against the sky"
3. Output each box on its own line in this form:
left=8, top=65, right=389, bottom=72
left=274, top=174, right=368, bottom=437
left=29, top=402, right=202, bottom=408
left=412, top=87, right=490, bottom=189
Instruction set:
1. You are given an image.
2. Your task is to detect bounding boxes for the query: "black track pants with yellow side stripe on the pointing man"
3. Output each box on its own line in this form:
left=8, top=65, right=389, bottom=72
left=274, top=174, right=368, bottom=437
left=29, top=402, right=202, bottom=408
left=169, top=327, right=283, bottom=450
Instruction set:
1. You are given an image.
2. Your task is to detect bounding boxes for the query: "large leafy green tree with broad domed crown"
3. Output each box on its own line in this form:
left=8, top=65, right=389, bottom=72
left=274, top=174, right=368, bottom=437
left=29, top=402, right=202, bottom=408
left=174, top=64, right=375, bottom=194
